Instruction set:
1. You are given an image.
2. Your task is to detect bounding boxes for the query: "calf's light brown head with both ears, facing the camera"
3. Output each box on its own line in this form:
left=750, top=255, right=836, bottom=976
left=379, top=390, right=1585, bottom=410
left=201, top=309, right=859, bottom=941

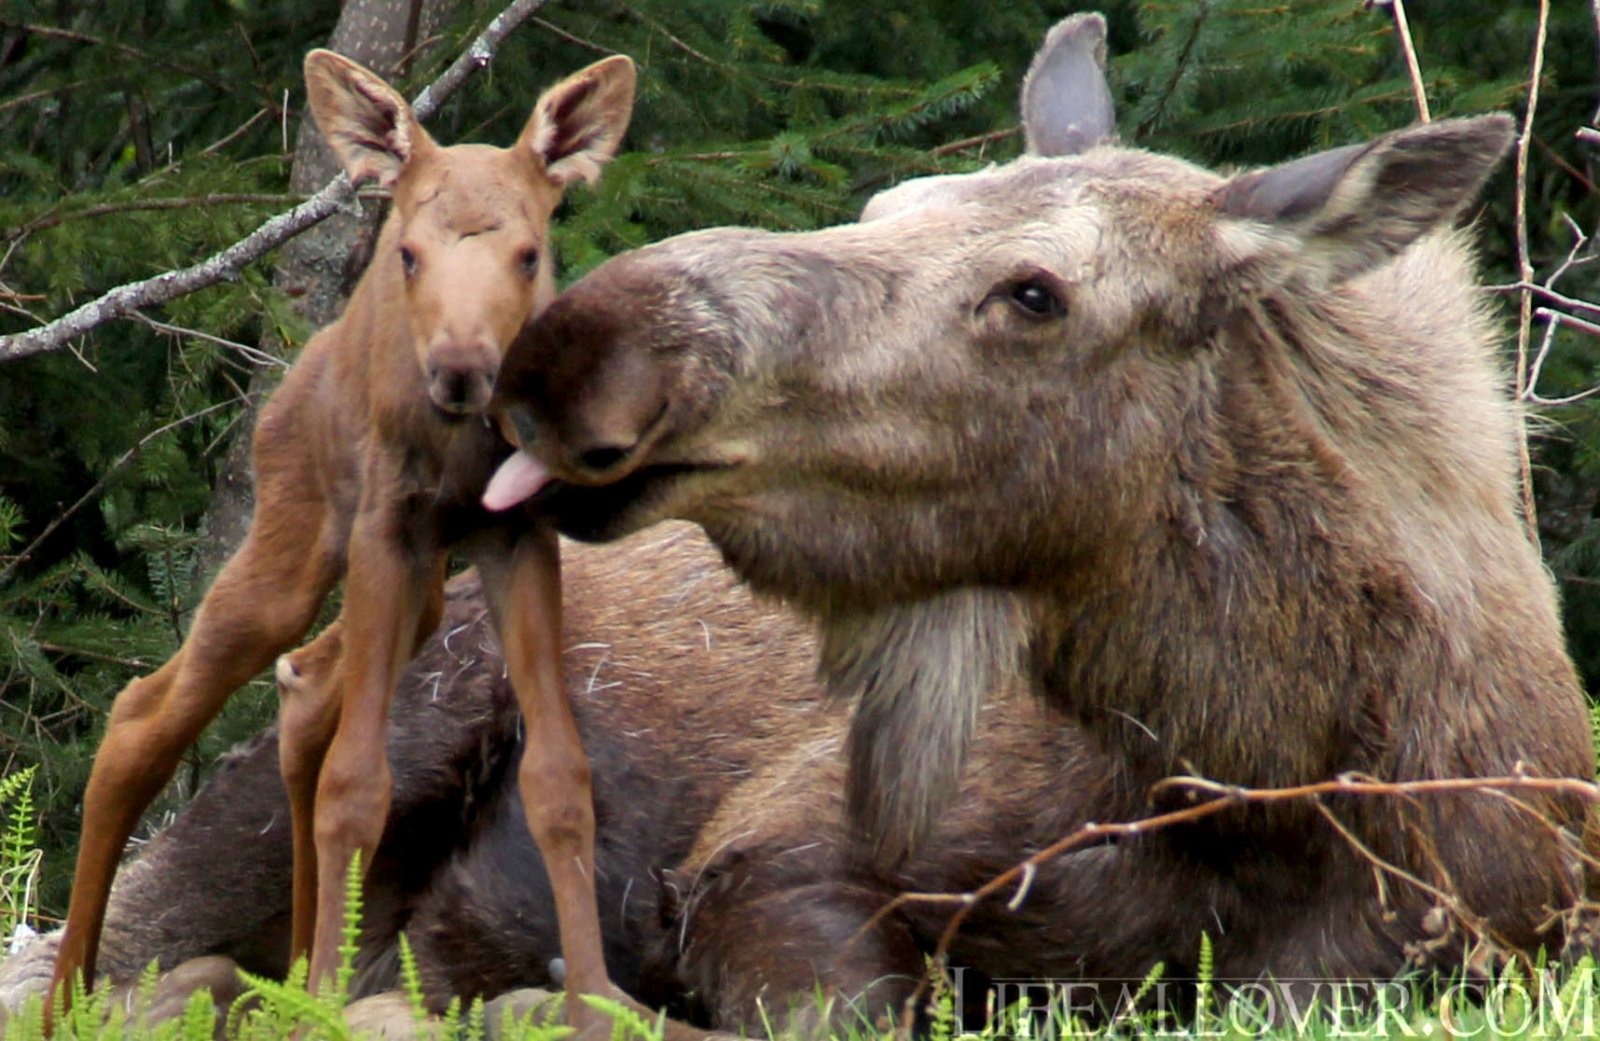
left=306, top=51, right=635, bottom=416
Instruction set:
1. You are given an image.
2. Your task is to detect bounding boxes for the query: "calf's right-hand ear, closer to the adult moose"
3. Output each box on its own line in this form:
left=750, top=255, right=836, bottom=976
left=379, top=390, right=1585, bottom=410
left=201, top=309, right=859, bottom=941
left=517, top=54, right=638, bottom=185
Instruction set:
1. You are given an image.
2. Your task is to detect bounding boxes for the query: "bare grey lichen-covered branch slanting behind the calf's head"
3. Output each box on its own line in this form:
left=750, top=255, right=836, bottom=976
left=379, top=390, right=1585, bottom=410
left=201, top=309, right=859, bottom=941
left=0, top=0, right=549, bottom=370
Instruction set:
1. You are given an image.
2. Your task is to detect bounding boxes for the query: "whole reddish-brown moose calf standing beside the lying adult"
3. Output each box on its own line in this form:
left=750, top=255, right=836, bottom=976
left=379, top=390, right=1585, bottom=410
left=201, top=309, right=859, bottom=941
left=53, top=51, right=635, bottom=1036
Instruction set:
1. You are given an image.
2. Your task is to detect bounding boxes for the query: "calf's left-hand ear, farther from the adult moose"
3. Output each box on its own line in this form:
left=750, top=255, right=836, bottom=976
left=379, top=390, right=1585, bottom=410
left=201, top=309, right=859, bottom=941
left=306, top=50, right=434, bottom=189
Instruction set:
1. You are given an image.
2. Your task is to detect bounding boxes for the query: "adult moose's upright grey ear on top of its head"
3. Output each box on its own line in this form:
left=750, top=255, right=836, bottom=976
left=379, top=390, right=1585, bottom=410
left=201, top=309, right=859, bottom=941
left=1022, top=13, right=1117, bottom=155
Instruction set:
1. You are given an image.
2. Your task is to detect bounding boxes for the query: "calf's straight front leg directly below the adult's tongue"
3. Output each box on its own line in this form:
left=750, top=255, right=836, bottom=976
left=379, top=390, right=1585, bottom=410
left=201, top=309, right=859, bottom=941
left=478, top=531, right=611, bottom=1033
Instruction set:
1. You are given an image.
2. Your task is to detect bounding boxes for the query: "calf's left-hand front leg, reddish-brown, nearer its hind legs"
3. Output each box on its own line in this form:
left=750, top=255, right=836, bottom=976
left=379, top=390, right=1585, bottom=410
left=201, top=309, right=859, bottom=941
left=301, top=512, right=442, bottom=990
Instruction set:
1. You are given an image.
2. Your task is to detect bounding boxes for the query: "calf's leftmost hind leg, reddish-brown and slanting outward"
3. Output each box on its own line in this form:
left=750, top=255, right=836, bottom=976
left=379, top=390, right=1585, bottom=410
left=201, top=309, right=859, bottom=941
left=51, top=497, right=339, bottom=1001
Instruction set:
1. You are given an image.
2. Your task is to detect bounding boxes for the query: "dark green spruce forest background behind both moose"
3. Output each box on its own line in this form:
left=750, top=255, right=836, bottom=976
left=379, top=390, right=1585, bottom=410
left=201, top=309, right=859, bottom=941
left=0, top=0, right=1600, bottom=918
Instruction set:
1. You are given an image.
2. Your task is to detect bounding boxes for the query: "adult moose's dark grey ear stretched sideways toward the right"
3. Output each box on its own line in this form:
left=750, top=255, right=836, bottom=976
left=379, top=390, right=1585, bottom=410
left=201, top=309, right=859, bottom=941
left=1216, top=115, right=1515, bottom=283
